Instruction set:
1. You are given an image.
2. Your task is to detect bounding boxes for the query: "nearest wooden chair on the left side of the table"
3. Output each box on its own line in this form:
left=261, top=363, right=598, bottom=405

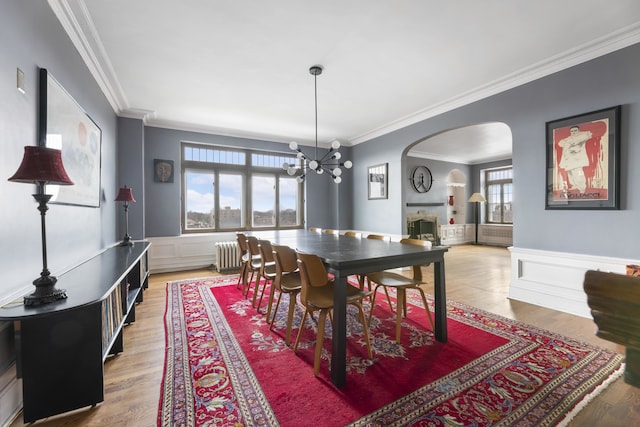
left=293, top=251, right=373, bottom=376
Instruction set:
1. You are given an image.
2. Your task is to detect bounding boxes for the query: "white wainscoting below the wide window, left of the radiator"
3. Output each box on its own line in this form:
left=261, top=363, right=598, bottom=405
left=147, top=233, right=236, bottom=273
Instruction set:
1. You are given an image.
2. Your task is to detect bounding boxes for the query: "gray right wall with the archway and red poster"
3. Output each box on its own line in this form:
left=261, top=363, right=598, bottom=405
left=353, top=45, right=640, bottom=259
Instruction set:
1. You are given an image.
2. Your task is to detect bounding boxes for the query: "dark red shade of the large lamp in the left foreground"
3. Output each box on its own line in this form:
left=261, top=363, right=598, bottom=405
left=9, top=145, right=73, bottom=185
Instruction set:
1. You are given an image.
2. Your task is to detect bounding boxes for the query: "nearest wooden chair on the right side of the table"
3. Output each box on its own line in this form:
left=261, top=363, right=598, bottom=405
left=366, top=239, right=435, bottom=344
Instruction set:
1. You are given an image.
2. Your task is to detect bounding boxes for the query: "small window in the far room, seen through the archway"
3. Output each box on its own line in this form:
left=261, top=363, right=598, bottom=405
left=484, top=166, right=513, bottom=224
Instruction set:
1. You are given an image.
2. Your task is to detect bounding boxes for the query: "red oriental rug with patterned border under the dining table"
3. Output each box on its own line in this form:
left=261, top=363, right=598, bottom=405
left=158, top=276, right=623, bottom=427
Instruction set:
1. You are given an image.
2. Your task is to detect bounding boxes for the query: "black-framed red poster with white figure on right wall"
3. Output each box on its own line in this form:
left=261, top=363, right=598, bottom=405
left=545, top=106, right=621, bottom=209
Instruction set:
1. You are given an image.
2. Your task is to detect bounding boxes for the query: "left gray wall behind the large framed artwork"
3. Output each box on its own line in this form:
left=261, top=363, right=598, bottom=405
left=0, top=1, right=117, bottom=298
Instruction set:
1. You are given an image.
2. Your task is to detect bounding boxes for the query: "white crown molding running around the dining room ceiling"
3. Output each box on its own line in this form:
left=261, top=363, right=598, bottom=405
left=47, top=0, right=640, bottom=147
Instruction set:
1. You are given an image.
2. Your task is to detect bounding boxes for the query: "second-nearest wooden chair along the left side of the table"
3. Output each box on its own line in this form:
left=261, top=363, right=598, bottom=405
left=267, top=245, right=302, bottom=345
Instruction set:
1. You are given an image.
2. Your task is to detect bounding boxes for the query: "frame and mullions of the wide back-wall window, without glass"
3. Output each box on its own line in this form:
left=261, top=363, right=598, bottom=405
left=180, top=141, right=305, bottom=234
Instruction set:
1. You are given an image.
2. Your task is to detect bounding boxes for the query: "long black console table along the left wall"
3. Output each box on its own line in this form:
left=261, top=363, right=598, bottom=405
left=0, top=242, right=150, bottom=422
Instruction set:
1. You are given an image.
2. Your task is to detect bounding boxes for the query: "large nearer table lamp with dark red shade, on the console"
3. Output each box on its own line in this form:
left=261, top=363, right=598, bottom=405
left=9, top=146, right=73, bottom=306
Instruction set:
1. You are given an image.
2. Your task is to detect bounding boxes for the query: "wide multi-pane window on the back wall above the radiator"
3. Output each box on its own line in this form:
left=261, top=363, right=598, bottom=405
left=182, top=143, right=304, bottom=233
